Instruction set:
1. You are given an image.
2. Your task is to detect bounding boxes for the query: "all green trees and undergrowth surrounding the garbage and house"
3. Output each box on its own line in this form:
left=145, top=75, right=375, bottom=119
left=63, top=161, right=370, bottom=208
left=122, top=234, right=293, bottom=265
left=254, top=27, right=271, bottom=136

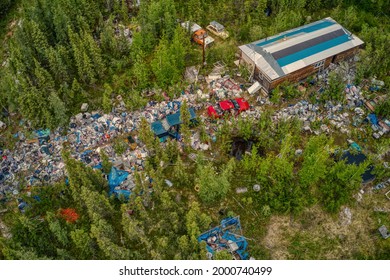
left=0, top=0, right=390, bottom=259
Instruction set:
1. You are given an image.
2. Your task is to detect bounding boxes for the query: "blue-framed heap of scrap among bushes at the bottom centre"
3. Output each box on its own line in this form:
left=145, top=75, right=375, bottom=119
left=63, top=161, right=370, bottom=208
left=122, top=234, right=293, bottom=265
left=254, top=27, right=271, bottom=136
left=198, top=216, right=249, bottom=260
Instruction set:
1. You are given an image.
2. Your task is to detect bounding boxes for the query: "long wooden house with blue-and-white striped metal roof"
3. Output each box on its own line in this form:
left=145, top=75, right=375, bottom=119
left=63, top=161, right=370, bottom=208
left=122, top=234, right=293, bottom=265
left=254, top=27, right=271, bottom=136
left=239, top=17, right=364, bottom=93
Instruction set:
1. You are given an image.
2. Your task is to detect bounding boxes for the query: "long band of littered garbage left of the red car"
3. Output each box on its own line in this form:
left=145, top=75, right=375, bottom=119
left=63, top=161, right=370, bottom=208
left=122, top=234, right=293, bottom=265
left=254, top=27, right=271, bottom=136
left=0, top=94, right=207, bottom=196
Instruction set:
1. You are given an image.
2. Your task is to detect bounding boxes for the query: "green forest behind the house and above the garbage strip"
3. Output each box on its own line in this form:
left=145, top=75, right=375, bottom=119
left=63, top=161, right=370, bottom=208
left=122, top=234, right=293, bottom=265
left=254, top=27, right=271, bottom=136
left=0, top=0, right=390, bottom=128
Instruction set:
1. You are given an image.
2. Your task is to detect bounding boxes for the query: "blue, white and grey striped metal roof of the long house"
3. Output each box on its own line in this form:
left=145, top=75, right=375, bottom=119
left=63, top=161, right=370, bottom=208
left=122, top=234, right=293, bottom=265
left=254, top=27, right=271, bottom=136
left=239, top=17, right=363, bottom=80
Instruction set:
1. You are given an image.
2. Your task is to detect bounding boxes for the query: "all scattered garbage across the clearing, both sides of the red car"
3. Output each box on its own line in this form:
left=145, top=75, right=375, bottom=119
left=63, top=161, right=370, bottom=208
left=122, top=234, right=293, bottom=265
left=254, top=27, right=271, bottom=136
left=0, top=60, right=390, bottom=199
